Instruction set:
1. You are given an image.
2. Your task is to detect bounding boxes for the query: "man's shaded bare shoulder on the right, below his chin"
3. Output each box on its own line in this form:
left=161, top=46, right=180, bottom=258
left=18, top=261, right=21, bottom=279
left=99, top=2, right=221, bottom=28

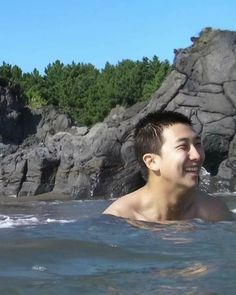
left=196, top=193, right=233, bottom=221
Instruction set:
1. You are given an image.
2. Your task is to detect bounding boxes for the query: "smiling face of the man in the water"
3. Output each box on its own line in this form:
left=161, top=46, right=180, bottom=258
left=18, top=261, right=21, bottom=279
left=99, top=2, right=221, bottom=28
left=160, top=124, right=205, bottom=188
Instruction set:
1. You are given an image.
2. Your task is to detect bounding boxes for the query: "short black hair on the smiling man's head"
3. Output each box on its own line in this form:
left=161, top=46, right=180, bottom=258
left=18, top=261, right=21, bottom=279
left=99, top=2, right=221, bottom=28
left=134, top=111, right=192, bottom=163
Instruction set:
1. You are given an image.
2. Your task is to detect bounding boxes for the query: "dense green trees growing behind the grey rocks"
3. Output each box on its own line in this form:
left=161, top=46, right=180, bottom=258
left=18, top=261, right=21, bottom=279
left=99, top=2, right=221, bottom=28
left=0, top=56, right=170, bottom=125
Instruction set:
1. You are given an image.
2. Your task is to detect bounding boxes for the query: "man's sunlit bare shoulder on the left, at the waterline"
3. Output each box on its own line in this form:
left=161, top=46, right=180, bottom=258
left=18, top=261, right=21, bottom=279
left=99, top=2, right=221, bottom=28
left=103, top=191, right=138, bottom=219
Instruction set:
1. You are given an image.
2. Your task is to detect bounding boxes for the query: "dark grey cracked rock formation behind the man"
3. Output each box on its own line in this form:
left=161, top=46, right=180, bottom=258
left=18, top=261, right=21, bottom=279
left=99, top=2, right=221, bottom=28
left=0, top=29, right=236, bottom=199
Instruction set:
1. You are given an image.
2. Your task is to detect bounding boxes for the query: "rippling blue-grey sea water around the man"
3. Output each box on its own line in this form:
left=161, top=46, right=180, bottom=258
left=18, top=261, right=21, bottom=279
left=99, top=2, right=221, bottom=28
left=0, top=194, right=236, bottom=295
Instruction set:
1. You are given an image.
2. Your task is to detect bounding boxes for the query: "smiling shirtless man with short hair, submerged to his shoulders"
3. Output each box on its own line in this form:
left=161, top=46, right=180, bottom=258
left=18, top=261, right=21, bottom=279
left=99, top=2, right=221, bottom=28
left=103, top=111, right=232, bottom=222
